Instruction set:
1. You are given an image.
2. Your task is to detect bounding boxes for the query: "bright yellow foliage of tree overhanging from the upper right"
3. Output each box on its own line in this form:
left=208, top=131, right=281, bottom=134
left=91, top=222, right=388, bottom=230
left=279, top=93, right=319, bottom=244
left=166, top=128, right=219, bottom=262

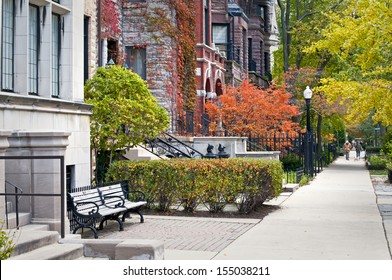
left=306, top=0, right=392, bottom=126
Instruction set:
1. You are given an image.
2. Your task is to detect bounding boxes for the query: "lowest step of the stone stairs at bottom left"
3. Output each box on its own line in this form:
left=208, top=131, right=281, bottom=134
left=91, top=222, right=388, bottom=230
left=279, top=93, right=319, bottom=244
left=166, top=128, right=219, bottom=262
left=10, top=243, right=83, bottom=260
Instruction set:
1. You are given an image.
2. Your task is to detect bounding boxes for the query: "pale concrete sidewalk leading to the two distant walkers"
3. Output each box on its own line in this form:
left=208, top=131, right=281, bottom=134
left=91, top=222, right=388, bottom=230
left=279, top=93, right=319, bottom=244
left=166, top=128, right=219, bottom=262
left=213, top=154, right=391, bottom=260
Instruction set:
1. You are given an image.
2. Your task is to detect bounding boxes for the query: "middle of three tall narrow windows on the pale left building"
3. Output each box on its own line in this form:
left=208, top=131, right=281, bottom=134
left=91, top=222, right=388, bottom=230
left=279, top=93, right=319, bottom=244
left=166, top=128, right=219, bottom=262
left=28, top=6, right=39, bottom=94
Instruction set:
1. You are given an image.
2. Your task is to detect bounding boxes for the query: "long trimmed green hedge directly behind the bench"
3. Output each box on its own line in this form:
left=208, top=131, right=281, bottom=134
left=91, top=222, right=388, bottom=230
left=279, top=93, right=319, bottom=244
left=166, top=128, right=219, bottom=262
left=107, top=159, right=283, bottom=213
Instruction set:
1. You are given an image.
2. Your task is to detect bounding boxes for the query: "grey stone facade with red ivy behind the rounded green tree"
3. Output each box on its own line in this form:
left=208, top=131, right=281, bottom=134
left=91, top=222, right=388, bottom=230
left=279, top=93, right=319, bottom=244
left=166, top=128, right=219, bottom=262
left=120, top=0, right=177, bottom=131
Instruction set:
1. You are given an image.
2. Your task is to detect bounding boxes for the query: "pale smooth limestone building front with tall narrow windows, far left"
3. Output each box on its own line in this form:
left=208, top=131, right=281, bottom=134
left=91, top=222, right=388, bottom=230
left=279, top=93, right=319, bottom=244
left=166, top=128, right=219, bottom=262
left=0, top=0, right=94, bottom=230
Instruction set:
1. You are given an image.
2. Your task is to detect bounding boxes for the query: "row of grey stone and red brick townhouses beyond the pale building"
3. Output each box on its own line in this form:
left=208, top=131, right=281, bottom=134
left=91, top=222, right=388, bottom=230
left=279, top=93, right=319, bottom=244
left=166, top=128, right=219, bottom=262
left=98, top=0, right=278, bottom=135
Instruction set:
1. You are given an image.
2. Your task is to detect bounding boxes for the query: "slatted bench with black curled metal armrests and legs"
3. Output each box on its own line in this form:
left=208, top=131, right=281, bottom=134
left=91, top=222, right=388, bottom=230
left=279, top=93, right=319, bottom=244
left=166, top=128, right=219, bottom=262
left=68, top=183, right=147, bottom=238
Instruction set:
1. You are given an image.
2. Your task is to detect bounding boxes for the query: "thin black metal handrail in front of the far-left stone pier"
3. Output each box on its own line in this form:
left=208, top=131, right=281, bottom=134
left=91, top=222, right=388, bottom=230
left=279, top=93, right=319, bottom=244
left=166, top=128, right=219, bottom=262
left=0, top=156, right=65, bottom=238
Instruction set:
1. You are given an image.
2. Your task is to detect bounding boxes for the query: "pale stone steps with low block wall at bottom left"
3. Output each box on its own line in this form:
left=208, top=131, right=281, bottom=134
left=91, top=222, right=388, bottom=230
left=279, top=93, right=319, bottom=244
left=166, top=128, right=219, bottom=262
left=7, top=224, right=164, bottom=260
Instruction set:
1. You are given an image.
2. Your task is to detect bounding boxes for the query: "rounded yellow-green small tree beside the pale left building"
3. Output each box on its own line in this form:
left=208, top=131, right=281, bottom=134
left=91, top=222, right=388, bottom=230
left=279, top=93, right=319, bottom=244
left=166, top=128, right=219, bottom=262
left=84, top=66, right=169, bottom=183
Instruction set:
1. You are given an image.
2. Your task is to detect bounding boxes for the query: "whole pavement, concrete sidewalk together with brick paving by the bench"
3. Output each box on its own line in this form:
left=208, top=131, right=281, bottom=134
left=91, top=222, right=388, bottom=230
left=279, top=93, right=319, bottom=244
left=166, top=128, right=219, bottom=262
left=95, top=153, right=392, bottom=260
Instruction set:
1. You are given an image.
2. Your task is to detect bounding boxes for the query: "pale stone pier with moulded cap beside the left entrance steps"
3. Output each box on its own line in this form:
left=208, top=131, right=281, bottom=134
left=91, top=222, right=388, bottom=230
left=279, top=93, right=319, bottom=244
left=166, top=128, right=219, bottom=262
left=5, top=131, right=71, bottom=232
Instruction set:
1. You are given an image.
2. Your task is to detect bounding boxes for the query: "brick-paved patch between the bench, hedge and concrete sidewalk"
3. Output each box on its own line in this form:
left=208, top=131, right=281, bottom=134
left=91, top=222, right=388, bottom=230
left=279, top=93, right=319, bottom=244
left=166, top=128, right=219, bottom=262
left=84, top=215, right=261, bottom=252
